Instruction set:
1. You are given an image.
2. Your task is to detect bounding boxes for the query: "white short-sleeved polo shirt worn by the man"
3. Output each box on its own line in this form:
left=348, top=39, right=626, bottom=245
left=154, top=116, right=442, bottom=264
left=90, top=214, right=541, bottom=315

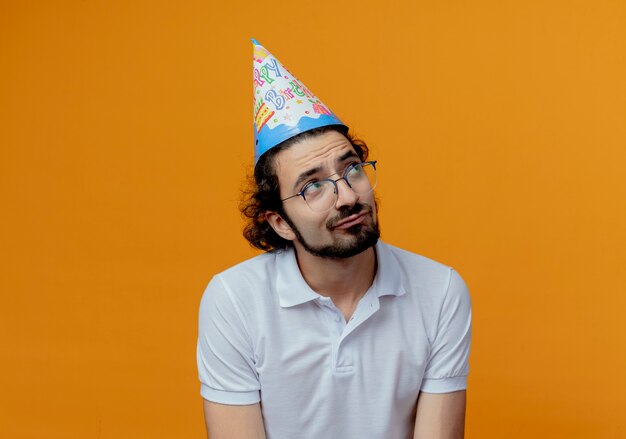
left=197, top=241, right=471, bottom=439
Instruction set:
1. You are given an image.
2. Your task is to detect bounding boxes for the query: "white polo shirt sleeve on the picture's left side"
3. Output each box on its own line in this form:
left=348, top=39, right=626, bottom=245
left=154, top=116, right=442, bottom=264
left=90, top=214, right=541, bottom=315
left=197, top=276, right=261, bottom=405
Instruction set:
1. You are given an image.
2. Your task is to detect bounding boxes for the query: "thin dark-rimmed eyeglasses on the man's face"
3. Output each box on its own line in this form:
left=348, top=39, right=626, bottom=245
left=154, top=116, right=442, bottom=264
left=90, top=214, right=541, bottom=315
left=281, top=160, right=376, bottom=212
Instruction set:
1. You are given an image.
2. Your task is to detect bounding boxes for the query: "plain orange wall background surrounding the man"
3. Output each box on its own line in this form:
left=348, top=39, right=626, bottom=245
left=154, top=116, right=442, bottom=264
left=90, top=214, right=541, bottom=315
left=0, top=0, right=626, bottom=439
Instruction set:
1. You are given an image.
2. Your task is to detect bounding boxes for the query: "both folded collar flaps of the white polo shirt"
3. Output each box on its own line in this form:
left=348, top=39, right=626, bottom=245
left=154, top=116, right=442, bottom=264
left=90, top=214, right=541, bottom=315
left=276, top=240, right=406, bottom=308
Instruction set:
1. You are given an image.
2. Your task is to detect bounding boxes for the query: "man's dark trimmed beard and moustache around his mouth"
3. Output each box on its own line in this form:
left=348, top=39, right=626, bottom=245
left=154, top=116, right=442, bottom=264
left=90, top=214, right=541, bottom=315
left=281, top=203, right=380, bottom=259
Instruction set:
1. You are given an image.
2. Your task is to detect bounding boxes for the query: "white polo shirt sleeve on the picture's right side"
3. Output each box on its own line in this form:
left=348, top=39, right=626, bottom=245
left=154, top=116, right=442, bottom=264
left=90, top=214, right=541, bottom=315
left=421, top=269, right=472, bottom=393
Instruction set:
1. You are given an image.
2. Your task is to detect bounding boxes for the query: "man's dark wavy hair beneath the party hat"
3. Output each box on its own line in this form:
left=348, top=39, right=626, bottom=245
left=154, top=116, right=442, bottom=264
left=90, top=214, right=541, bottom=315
left=239, top=125, right=369, bottom=251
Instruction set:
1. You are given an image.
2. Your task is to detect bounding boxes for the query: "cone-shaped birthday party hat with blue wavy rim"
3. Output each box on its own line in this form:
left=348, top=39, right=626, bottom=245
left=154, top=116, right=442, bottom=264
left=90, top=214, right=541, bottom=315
left=252, top=39, right=348, bottom=164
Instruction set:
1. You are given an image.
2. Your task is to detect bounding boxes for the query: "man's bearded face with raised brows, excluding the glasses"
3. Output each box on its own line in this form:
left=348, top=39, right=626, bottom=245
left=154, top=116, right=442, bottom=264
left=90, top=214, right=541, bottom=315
left=275, top=131, right=380, bottom=258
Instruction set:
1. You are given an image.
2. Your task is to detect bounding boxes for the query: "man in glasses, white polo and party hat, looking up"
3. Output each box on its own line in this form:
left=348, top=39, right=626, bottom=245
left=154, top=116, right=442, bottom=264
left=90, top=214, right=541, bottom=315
left=198, top=40, right=471, bottom=439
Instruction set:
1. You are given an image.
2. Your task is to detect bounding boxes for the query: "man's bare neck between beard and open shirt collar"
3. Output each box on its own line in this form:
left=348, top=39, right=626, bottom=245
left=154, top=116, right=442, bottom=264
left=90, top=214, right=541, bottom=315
left=295, top=243, right=376, bottom=307
